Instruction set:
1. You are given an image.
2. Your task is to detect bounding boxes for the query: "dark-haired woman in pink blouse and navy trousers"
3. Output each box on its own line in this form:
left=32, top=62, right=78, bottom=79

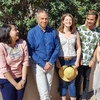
left=0, top=24, right=29, bottom=100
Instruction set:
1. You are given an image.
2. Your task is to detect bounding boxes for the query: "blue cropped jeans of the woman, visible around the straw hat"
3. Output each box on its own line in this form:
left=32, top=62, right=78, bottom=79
left=59, top=57, right=76, bottom=97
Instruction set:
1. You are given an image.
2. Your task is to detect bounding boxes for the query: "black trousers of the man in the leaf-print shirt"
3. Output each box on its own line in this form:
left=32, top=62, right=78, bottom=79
left=76, top=65, right=91, bottom=100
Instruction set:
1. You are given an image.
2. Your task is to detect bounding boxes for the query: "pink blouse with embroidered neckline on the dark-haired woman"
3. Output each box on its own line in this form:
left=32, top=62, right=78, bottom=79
left=0, top=39, right=29, bottom=79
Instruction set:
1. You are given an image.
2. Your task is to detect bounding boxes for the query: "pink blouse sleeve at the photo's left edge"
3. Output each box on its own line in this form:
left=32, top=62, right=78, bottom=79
left=0, top=43, right=9, bottom=74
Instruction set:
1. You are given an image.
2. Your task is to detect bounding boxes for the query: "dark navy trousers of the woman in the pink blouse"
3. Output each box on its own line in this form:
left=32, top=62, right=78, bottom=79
left=0, top=78, right=26, bottom=100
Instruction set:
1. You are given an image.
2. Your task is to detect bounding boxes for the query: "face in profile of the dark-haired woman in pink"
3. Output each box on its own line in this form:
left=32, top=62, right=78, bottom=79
left=9, top=25, right=19, bottom=41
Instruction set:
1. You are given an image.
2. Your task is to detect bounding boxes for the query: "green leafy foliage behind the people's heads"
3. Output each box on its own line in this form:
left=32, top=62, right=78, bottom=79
left=0, top=0, right=100, bottom=38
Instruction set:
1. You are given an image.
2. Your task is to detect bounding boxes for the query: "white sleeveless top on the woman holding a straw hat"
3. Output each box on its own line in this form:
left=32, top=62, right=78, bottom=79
left=59, top=32, right=76, bottom=57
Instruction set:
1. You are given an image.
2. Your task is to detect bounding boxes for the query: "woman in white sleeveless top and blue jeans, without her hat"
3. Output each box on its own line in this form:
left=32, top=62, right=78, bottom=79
left=56, top=13, right=81, bottom=100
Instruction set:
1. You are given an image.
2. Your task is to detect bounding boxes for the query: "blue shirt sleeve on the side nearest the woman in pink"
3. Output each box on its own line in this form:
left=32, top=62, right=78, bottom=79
left=27, top=31, right=46, bottom=68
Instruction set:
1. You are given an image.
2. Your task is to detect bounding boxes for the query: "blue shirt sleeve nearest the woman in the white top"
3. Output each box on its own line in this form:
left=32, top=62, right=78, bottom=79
left=49, top=31, right=60, bottom=64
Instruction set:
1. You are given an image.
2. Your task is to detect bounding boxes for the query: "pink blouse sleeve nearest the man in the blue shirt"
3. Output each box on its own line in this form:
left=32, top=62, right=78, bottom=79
left=22, top=41, right=29, bottom=67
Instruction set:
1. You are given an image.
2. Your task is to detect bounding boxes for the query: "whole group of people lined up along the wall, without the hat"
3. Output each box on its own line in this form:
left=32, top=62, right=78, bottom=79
left=0, top=9, right=100, bottom=100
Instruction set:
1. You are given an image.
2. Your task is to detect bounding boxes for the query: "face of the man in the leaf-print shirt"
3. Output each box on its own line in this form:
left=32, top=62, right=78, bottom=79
left=86, top=15, right=96, bottom=28
